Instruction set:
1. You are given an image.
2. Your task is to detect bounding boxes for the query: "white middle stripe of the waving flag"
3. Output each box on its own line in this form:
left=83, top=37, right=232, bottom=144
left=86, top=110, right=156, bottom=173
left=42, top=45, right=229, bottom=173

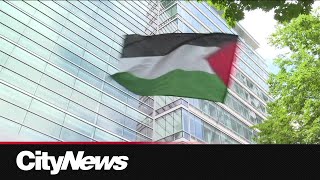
left=120, top=45, right=219, bottom=79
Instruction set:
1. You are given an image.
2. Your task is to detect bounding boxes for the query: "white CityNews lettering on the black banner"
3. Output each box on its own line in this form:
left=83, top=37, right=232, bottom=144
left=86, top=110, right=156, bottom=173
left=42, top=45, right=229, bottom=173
left=16, top=151, right=129, bottom=175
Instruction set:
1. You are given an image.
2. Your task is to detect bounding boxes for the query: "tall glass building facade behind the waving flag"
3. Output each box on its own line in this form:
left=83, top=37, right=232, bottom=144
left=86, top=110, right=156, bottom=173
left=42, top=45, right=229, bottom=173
left=0, top=1, right=270, bottom=144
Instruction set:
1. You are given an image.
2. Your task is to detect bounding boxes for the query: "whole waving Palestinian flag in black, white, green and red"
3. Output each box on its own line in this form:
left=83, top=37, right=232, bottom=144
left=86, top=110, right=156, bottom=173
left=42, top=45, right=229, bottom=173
left=112, top=33, right=238, bottom=102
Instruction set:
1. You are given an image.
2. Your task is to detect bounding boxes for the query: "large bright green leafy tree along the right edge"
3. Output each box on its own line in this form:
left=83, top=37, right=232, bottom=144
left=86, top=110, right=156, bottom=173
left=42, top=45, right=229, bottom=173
left=252, top=9, right=320, bottom=144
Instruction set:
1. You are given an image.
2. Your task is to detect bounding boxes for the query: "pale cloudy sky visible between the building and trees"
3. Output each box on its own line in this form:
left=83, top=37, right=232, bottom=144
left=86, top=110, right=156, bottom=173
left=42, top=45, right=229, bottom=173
left=239, top=1, right=320, bottom=73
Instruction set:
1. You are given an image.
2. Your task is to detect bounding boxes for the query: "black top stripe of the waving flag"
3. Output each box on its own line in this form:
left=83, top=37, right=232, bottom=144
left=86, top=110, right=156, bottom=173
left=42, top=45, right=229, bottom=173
left=121, top=33, right=238, bottom=58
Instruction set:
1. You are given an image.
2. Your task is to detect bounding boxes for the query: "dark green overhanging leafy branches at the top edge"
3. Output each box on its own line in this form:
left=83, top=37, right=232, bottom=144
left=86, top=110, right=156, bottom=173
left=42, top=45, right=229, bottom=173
left=197, top=0, right=314, bottom=27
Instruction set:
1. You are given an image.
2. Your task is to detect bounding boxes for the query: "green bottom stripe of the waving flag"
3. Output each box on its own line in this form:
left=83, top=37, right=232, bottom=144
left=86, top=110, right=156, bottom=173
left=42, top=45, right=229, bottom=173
left=112, top=70, right=227, bottom=102
